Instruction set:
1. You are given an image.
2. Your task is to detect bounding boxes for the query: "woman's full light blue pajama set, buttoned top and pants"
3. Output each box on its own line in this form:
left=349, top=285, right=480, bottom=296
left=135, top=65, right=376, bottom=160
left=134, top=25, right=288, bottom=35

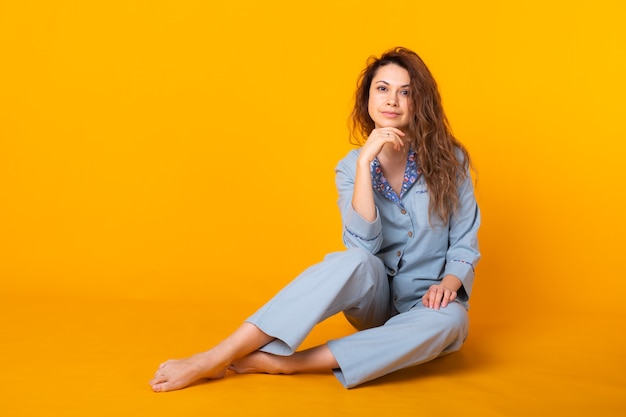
left=247, top=150, right=480, bottom=388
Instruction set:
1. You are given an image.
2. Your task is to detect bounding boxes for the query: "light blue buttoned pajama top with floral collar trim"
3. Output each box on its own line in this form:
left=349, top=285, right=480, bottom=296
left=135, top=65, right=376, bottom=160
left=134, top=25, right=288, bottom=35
left=335, top=149, right=480, bottom=313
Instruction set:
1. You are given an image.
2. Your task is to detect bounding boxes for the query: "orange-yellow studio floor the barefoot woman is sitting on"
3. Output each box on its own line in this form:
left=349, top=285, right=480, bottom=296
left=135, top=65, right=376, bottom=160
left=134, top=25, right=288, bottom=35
left=0, top=294, right=626, bottom=417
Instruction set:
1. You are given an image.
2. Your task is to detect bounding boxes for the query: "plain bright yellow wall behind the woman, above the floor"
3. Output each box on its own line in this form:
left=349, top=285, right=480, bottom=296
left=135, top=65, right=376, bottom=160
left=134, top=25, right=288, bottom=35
left=0, top=0, right=626, bottom=318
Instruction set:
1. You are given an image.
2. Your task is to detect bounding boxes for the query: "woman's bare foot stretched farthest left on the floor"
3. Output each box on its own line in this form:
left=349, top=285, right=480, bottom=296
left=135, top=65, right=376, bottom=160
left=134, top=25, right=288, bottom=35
left=150, top=351, right=228, bottom=392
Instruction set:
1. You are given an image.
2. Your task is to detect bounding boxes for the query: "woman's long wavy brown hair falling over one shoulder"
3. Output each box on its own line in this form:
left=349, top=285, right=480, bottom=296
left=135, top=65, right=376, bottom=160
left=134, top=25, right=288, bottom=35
left=350, top=47, right=471, bottom=224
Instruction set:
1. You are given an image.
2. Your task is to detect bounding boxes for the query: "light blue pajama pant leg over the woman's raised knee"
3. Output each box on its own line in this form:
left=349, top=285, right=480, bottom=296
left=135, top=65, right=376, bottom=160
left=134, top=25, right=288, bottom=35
left=246, top=249, right=393, bottom=355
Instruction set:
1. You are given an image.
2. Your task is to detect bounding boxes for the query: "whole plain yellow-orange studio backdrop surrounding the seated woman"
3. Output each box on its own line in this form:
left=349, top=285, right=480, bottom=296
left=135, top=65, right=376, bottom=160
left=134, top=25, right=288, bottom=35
left=0, top=0, right=626, bottom=415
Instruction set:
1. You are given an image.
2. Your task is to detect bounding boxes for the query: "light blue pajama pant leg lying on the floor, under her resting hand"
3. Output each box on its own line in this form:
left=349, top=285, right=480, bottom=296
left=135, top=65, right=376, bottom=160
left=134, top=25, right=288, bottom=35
left=328, top=301, right=469, bottom=388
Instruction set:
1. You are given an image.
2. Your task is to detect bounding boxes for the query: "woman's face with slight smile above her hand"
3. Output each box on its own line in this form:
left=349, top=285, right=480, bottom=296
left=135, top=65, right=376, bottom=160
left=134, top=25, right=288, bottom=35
left=368, top=64, right=412, bottom=130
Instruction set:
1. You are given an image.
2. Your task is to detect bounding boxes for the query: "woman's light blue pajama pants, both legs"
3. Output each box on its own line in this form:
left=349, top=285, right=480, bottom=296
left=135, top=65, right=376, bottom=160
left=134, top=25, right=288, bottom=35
left=246, top=248, right=469, bottom=388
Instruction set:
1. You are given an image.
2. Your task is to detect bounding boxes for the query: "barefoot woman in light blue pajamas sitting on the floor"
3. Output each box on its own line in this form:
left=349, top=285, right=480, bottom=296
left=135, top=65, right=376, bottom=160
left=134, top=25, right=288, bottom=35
left=150, top=48, right=480, bottom=392
